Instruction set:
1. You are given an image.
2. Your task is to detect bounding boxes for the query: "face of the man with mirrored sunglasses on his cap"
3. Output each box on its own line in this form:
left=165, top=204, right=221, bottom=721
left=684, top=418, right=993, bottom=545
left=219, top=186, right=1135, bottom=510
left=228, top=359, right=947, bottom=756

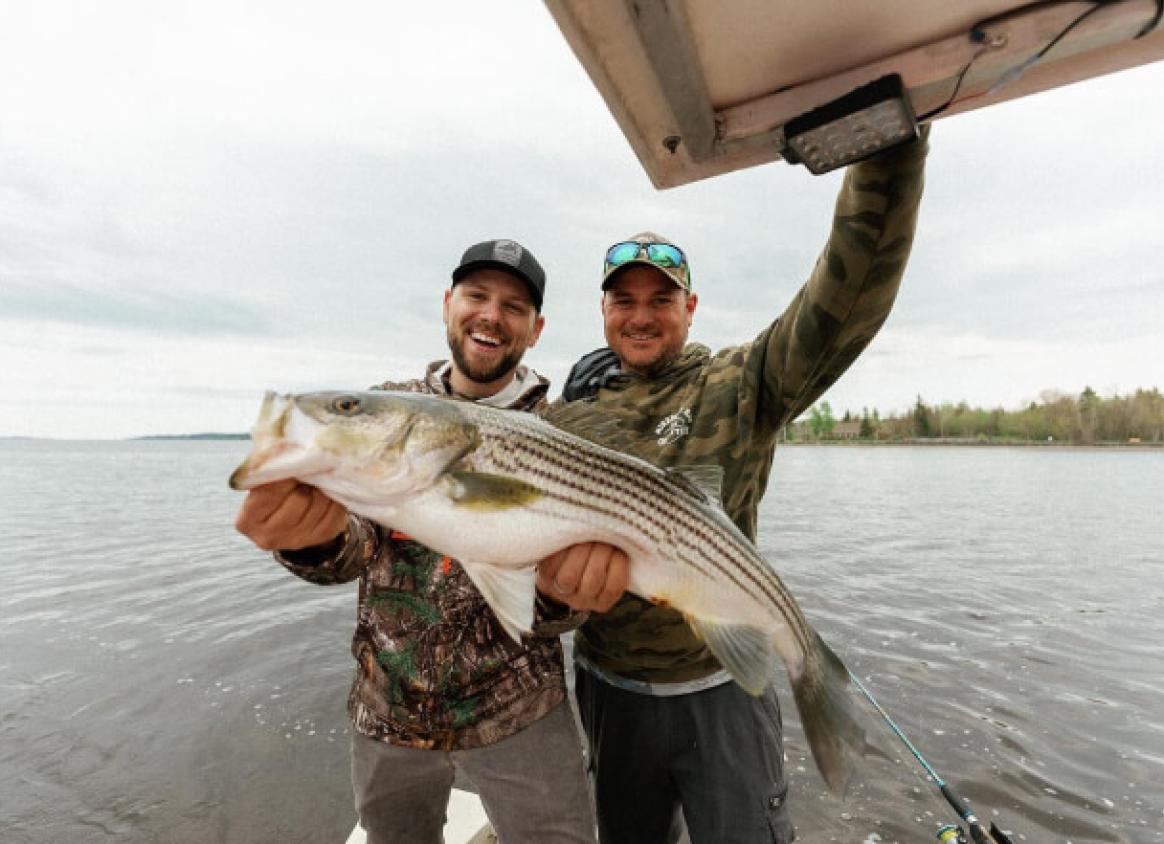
left=602, top=265, right=697, bottom=376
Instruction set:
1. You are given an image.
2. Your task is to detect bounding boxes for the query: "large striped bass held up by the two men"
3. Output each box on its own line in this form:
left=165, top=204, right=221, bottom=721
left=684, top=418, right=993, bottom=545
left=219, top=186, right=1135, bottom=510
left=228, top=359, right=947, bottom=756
left=230, top=391, right=865, bottom=792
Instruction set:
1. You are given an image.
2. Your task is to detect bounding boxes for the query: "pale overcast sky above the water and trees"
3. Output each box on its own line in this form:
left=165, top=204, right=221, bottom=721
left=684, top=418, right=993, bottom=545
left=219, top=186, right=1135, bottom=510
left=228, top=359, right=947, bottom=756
left=0, top=0, right=1164, bottom=438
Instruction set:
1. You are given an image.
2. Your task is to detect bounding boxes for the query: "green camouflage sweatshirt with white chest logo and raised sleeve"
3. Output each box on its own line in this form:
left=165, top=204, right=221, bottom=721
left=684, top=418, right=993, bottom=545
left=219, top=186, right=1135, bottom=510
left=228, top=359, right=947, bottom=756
left=563, top=132, right=929, bottom=683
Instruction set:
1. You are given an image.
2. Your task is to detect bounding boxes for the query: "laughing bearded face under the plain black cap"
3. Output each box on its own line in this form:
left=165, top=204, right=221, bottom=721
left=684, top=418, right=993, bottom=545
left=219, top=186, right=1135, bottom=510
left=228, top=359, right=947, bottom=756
left=445, top=268, right=545, bottom=398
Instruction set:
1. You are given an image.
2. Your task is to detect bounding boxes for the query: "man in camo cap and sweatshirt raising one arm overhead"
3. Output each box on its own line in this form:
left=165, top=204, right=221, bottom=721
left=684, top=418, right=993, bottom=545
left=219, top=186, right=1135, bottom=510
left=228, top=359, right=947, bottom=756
left=539, top=128, right=929, bottom=844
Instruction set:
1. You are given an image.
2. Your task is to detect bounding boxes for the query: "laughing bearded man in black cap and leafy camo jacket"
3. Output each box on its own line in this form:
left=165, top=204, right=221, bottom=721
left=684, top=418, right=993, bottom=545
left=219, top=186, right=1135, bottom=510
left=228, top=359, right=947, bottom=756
left=236, top=240, right=626, bottom=844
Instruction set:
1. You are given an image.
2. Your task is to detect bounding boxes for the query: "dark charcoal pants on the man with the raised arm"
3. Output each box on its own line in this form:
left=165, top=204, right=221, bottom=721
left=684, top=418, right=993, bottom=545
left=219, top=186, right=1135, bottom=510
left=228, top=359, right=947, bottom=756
left=575, top=666, right=794, bottom=844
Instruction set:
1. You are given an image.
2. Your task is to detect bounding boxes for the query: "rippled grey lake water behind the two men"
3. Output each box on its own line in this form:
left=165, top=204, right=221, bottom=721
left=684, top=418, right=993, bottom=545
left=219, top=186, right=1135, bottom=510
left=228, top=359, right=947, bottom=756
left=0, top=441, right=1164, bottom=844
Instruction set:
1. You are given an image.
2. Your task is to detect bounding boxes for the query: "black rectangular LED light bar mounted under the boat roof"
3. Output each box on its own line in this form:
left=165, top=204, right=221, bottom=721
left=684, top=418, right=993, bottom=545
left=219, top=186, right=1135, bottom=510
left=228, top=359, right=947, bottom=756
left=781, top=73, right=917, bottom=175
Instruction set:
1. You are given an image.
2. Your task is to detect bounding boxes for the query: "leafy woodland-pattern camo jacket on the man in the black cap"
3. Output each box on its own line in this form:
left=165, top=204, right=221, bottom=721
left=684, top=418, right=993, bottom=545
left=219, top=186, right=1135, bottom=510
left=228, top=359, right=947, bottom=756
left=276, top=362, right=585, bottom=750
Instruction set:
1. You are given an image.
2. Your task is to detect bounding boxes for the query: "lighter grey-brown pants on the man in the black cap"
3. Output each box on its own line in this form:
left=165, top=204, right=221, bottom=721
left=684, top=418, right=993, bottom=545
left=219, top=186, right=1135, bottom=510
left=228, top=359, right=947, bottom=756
left=352, top=703, right=595, bottom=844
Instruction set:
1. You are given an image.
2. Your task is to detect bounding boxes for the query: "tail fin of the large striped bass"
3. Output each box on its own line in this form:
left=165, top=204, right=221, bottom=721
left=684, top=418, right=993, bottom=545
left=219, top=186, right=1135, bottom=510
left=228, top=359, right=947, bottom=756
left=792, top=631, right=865, bottom=795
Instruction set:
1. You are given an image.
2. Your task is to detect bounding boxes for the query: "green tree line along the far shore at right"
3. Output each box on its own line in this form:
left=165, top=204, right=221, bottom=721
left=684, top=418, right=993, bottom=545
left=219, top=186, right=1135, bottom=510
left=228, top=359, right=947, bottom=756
left=786, top=386, right=1164, bottom=445
